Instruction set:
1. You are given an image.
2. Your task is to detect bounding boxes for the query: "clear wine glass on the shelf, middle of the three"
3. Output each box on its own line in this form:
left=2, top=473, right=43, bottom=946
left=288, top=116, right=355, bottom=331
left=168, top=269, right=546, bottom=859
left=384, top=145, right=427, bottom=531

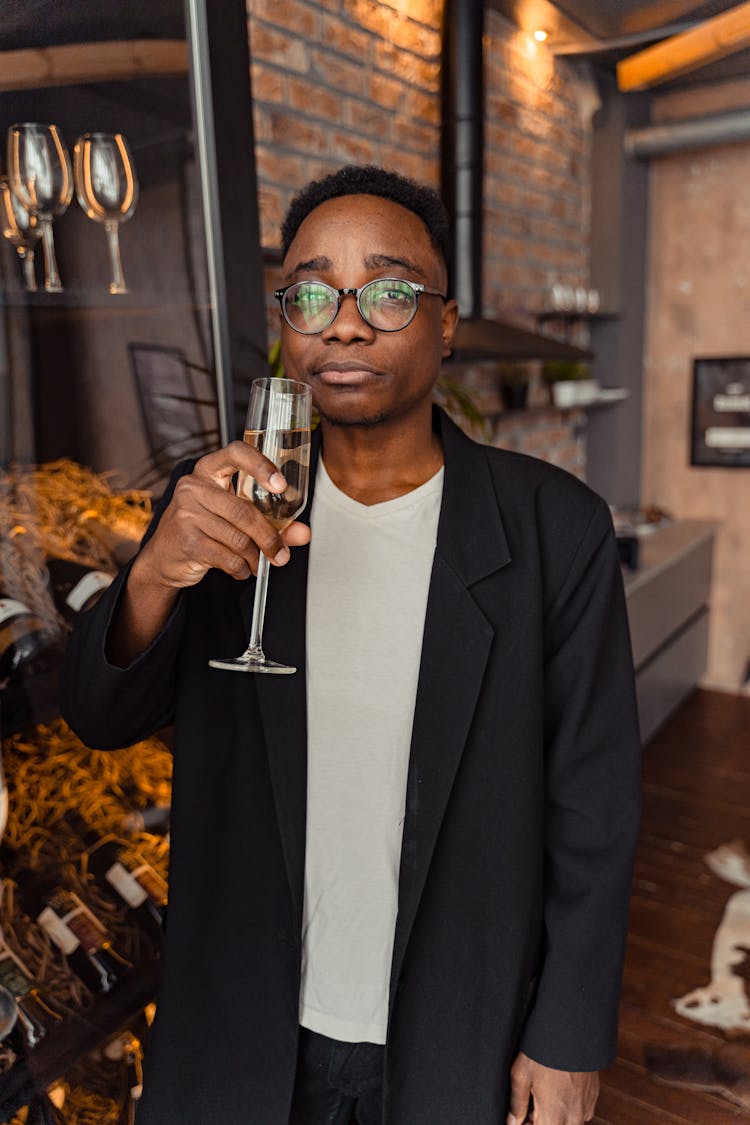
left=8, top=123, right=73, bottom=293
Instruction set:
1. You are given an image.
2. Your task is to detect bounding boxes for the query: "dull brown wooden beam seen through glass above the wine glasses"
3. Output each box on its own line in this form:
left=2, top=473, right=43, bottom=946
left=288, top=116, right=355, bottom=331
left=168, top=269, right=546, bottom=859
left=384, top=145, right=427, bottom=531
left=0, top=39, right=188, bottom=92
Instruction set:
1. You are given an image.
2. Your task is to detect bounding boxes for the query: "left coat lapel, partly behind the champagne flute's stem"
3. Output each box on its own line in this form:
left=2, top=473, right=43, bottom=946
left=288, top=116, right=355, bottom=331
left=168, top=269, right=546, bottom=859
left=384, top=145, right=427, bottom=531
left=242, top=433, right=320, bottom=933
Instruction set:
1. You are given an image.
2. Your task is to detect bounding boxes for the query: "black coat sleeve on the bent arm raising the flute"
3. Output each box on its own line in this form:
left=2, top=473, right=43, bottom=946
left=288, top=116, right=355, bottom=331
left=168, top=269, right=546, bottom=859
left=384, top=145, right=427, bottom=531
left=61, top=460, right=195, bottom=750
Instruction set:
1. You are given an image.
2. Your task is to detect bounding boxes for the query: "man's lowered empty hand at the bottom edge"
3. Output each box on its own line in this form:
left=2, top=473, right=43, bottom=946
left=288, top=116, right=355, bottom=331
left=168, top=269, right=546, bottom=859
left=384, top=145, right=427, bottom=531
left=507, top=1052, right=599, bottom=1125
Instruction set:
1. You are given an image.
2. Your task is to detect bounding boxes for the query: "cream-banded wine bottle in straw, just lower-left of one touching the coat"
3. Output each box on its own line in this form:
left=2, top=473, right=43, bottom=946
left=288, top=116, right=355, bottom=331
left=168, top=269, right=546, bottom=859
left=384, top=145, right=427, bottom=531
left=18, top=872, right=128, bottom=992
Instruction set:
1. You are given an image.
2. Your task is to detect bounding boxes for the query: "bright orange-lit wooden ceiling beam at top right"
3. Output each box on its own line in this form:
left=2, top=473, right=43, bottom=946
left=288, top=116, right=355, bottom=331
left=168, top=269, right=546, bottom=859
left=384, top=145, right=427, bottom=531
left=617, top=0, right=750, bottom=92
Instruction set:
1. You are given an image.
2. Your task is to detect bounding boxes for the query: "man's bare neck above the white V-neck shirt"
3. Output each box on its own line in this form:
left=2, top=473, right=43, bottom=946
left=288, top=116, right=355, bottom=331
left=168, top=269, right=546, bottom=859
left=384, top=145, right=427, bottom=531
left=320, top=409, right=443, bottom=504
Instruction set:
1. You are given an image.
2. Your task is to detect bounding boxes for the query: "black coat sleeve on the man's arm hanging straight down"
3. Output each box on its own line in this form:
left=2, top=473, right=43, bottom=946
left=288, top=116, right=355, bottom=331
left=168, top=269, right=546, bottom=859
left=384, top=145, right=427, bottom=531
left=521, top=500, right=641, bottom=1071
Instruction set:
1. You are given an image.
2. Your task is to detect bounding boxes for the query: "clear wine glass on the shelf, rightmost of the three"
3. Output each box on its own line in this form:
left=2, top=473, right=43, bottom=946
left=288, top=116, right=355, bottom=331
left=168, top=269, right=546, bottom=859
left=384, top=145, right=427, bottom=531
left=73, top=133, right=138, bottom=293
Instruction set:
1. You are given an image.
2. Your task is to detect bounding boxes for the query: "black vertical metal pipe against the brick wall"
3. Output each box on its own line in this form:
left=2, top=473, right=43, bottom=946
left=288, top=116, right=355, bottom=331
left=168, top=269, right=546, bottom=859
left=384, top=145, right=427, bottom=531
left=441, top=0, right=485, bottom=317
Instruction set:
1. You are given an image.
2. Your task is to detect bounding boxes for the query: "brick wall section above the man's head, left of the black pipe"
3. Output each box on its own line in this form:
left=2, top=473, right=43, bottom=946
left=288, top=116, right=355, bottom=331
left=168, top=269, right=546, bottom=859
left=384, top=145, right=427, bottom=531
left=247, top=0, right=442, bottom=246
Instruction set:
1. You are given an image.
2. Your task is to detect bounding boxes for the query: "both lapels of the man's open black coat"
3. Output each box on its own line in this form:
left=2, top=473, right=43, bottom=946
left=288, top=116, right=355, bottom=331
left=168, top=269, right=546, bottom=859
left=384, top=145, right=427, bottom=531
left=249, top=408, right=510, bottom=954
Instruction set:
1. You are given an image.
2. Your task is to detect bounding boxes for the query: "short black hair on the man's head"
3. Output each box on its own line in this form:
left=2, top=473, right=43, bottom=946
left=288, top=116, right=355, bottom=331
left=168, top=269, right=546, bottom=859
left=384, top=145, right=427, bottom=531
left=281, top=164, right=451, bottom=266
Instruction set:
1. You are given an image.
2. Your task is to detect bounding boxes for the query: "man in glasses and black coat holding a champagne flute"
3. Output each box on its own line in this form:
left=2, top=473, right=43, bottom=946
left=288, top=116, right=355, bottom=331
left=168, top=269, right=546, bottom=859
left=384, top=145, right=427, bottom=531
left=61, top=160, right=639, bottom=1125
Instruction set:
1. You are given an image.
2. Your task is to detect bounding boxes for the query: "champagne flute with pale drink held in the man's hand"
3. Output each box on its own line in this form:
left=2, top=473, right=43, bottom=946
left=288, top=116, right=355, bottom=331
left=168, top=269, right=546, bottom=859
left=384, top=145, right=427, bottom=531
left=208, top=379, right=311, bottom=674
